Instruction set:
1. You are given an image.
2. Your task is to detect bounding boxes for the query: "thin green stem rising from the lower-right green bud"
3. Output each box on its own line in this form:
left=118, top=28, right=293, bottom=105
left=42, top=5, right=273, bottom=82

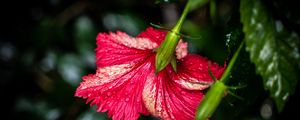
left=220, top=42, right=244, bottom=83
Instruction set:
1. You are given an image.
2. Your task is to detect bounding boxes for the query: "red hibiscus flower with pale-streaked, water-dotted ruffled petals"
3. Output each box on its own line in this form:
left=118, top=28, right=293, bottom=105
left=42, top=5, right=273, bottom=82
left=75, top=28, right=224, bottom=120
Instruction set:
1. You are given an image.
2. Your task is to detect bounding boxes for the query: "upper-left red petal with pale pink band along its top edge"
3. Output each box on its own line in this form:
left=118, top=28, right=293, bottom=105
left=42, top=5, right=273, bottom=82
left=96, top=32, right=158, bottom=67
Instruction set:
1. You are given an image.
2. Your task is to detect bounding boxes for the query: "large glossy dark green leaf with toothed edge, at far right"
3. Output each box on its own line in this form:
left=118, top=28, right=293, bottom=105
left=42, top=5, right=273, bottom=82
left=240, top=0, right=300, bottom=111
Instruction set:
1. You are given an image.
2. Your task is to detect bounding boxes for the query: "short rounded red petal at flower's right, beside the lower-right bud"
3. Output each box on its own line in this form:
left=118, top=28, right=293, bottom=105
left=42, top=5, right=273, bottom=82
left=175, top=55, right=225, bottom=90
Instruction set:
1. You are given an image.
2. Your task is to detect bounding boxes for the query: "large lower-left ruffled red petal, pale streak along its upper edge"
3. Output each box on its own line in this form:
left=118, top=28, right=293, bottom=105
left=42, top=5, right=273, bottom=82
left=75, top=55, right=154, bottom=120
